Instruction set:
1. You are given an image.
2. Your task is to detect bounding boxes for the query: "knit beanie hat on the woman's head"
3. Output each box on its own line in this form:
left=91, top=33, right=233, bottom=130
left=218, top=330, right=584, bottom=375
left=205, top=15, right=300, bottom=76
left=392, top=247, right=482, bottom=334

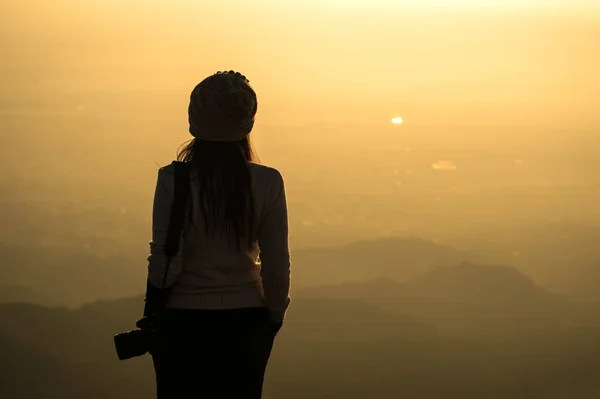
left=188, top=71, right=258, bottom=142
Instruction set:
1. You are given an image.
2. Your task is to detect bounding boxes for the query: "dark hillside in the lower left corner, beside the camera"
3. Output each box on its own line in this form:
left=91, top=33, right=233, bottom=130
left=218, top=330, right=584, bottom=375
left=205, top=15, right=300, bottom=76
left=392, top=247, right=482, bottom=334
left=0, top=304, right=153, bottom=399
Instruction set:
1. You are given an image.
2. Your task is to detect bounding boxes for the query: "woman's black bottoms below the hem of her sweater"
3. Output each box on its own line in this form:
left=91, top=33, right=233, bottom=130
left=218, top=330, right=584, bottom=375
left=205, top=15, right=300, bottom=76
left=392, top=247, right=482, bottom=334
left=152, top=308, right=274, bottom=399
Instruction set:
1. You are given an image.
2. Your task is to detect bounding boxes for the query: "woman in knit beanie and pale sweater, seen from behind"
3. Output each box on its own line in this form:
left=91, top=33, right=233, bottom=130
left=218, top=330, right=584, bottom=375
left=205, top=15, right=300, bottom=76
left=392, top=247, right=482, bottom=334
left=145, top=71, right=290, bottom=399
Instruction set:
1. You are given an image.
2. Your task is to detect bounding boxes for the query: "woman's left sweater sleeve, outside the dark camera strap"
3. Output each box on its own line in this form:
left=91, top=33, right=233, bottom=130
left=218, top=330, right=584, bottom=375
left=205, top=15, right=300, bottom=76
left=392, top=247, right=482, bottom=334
left=148, top=166, right=182, bottom=288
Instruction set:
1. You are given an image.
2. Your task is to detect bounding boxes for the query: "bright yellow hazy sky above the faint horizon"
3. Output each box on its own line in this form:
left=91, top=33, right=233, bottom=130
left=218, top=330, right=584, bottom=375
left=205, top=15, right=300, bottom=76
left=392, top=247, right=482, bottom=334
left=0, top=0, right=600, bottom=125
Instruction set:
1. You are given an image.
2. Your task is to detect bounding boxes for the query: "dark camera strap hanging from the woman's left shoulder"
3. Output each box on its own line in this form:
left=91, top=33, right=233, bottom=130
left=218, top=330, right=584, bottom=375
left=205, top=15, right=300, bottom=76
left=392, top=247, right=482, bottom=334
left=162, top=161, right=191, bottom=289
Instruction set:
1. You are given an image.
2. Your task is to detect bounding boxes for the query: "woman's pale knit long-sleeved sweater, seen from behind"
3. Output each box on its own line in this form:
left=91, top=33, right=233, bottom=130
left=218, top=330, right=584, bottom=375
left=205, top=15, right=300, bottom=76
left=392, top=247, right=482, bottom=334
left=148, top=163, right=290, bottom=321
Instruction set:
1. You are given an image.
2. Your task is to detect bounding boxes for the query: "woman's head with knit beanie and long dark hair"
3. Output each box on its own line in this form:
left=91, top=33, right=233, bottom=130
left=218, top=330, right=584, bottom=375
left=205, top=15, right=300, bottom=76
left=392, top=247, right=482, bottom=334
left=177, top=71, right=258, bottom=249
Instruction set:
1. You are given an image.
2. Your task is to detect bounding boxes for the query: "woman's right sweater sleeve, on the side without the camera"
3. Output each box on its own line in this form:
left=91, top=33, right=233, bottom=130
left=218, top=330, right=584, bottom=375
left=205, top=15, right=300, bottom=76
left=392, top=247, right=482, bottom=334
left=258, top=172, right=290, bottom=322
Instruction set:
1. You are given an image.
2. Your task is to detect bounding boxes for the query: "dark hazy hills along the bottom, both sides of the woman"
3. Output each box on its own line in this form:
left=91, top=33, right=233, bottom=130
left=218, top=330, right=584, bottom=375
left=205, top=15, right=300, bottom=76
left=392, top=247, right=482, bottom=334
left=0, top=264, right=600, bottom=399
